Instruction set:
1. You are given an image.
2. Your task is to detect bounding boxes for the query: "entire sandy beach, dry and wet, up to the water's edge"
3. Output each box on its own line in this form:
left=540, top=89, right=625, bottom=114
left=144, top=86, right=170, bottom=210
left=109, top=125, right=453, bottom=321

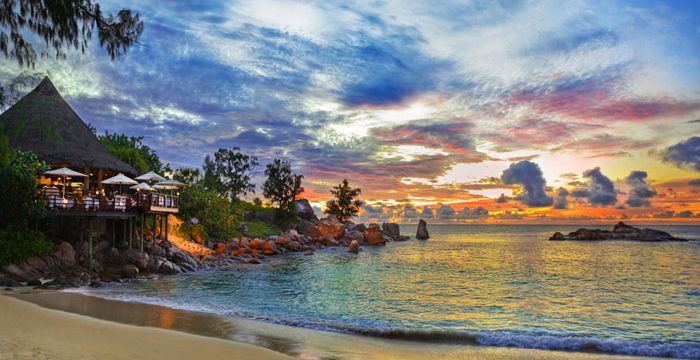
left=0, top=290, right=649, bottom=360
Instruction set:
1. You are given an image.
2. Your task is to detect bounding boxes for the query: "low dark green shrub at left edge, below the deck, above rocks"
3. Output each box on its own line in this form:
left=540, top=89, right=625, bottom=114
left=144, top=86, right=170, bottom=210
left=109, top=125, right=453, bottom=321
left=0, top=229, right=56, bottom=265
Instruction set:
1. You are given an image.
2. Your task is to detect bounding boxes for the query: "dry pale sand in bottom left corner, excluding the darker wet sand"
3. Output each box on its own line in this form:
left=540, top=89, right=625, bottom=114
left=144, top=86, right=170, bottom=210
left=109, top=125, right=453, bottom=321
left=0, top=295, right=289, bottom=360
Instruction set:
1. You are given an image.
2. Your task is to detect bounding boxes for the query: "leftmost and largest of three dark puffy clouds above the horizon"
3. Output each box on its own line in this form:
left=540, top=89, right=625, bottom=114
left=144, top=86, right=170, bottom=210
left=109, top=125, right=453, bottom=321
left=501, top=160, right=554, bottom=207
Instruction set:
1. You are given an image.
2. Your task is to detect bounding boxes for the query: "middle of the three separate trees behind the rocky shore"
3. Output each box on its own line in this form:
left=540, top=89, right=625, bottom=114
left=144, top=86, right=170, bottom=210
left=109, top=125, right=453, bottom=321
left=263, top=159, right=304, bottom=211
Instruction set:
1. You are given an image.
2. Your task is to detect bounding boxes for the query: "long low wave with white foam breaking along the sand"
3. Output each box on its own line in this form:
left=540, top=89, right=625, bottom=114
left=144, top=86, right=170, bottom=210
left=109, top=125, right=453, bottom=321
left=63, top=289, right=700, bottom=359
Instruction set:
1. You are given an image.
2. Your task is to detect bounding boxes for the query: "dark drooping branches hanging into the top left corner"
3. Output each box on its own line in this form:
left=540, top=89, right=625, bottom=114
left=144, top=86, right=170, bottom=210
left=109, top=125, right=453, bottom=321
left=0, top=0, right=143, bottom=67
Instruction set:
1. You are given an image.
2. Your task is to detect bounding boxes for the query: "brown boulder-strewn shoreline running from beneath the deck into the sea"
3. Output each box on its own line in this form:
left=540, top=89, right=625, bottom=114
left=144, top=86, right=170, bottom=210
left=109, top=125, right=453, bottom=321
left=0, top=200, right=430, bottom=289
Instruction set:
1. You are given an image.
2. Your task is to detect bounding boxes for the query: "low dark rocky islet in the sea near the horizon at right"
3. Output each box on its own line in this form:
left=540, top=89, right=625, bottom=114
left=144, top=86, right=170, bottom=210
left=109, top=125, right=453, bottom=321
left=549, top=221, right=688, bottom=242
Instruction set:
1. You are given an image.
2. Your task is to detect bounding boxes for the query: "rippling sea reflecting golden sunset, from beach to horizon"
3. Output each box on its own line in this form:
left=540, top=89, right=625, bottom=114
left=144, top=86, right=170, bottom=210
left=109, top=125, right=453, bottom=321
left=79, top=225, right=700, bottom=358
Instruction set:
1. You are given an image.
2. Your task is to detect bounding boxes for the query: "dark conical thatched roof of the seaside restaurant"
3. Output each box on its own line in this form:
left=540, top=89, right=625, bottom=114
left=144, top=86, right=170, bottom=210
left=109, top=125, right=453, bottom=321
left=0, top=77, right=137, bottom=175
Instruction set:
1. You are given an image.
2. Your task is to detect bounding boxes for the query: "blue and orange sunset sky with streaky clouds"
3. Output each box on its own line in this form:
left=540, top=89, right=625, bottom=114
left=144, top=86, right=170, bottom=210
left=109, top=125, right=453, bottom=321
left=0, top=0, right=700, bottom=222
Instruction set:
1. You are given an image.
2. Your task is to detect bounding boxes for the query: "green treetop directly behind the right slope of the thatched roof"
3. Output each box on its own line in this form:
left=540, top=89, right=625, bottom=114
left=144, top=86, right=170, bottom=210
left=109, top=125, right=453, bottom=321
left=98, top=132, right=164, bottom=174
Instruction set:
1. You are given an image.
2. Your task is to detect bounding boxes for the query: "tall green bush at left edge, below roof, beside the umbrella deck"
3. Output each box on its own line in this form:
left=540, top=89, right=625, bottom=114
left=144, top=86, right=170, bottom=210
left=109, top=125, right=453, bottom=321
left=0, top=142, right=48, bottom=230
